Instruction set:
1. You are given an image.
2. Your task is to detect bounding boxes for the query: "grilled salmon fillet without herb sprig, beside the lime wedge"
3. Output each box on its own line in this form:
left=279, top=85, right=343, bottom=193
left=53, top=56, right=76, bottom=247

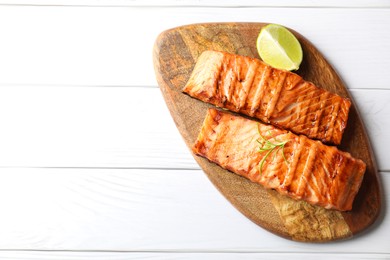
left=183, top=51, right=351, bottom=145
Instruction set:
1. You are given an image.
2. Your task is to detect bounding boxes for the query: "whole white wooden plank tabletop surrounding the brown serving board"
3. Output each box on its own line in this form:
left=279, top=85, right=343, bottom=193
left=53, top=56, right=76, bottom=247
left=0, top=0, right=390, bottom=259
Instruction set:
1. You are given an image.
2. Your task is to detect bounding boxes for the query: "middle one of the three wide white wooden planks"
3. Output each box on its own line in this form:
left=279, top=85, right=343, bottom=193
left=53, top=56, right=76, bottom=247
left=0, top=86, right=390, bottom=171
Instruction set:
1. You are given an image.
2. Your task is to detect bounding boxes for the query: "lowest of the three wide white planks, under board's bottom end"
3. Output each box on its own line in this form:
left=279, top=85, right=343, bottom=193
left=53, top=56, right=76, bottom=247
left=0, top=168, right=390, bottom=254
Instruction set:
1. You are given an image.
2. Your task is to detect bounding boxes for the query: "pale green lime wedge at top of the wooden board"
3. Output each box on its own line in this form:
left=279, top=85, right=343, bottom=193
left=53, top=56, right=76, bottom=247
left=256, top=24, right=302, bottom=70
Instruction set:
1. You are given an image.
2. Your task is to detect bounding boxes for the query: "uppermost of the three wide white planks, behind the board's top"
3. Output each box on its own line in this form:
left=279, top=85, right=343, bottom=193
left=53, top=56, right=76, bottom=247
left=0, top=6, right=390, bottom=88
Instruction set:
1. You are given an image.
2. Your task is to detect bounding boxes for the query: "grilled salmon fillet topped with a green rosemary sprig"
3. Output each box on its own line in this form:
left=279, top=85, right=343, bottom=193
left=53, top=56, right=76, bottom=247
left=192, top=109, right=366, bottom=211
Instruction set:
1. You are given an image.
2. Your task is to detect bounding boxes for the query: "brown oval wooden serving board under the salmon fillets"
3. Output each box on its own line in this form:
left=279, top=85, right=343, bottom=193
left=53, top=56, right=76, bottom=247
left=153, top=23, right=381, bottom=242
